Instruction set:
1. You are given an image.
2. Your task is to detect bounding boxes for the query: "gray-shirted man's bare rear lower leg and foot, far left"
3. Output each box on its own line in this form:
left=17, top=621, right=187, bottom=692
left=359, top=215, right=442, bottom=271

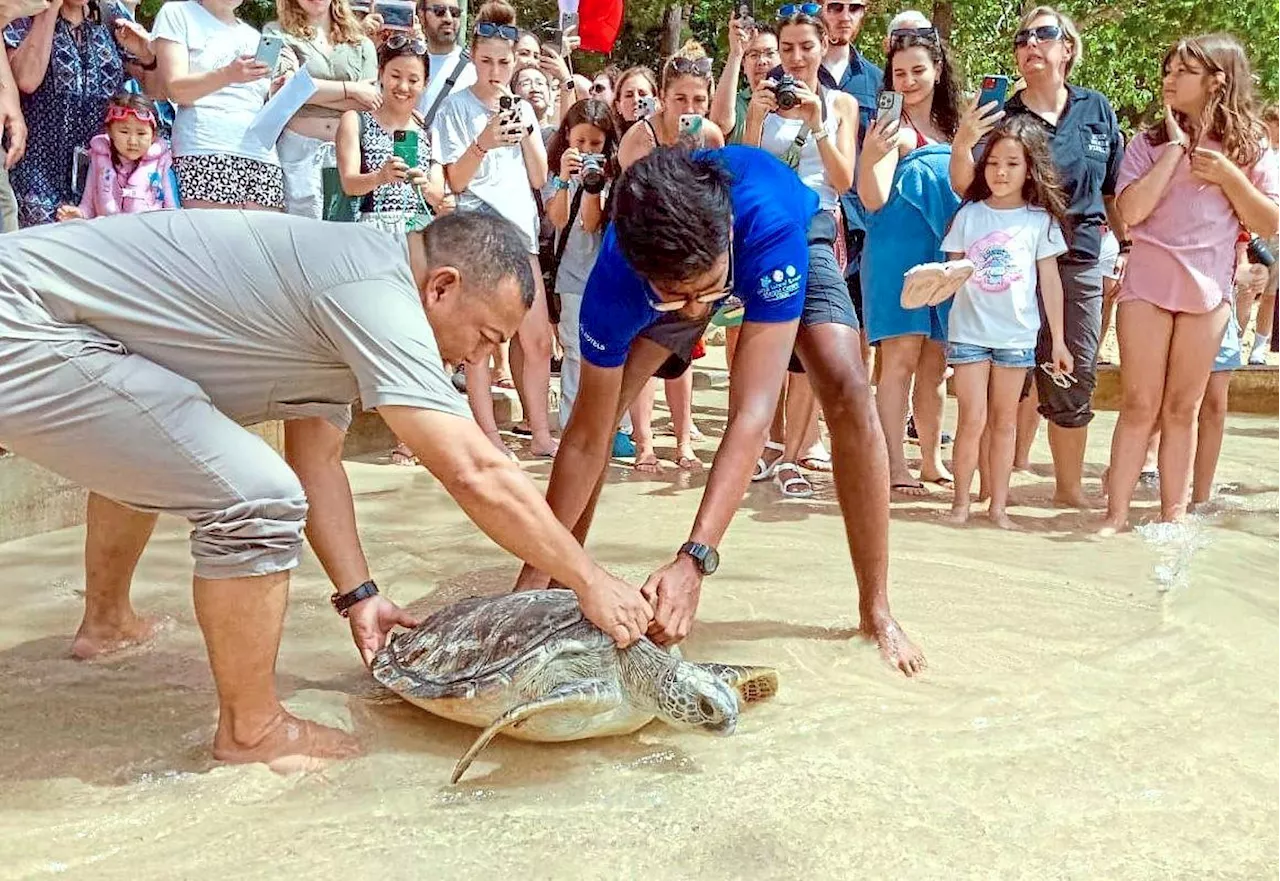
left=72, top=493, right=159, bottom=661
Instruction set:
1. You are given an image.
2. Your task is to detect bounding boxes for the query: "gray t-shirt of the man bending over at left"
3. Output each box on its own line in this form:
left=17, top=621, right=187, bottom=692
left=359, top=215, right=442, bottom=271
left=0, top=210, right=471, bottom=426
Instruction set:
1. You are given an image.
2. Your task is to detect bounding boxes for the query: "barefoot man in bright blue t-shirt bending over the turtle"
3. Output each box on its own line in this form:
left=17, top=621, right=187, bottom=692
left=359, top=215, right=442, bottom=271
left=517, top=146, right=924, bottom=676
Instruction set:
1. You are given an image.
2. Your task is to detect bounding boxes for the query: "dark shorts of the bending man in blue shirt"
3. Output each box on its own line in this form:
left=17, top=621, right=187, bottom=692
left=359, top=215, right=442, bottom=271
left=640, top=211, right=861, bottom=379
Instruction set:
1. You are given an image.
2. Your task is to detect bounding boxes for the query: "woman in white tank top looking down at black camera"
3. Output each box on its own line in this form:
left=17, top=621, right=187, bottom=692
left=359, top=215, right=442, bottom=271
left=742, top=12, right=858, bottom=498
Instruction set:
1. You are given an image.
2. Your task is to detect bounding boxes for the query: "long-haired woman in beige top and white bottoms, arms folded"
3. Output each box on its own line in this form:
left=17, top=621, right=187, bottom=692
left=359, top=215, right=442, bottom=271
left=262, top=0, right=373, bottom=218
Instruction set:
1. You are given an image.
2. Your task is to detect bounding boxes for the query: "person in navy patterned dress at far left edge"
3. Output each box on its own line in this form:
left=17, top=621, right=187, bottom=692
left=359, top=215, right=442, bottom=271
left=0, top=0, right=159, bottom=227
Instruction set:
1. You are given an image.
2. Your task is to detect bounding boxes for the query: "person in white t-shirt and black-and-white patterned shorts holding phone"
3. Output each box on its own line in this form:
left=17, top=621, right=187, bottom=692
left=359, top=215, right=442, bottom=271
left=155, top=0, right=284, bottom=211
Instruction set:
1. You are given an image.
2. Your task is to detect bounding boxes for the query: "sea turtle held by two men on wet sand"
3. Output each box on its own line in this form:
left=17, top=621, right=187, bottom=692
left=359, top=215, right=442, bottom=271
left=372, top=590, right=778, bottom=782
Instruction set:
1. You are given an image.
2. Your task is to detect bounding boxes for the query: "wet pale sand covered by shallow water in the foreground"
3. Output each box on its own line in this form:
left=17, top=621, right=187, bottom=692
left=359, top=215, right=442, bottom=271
left=0, top=391, right=1280, bottom=881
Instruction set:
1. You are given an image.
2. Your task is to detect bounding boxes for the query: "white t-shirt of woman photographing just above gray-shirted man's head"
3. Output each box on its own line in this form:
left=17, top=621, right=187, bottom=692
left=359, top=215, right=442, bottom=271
left=431, top=88, right=538, bottom=254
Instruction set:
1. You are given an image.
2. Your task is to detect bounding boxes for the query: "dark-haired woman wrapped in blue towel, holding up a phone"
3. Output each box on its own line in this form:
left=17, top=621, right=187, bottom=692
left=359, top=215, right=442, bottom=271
left=858, top=28, right=961, bottom=497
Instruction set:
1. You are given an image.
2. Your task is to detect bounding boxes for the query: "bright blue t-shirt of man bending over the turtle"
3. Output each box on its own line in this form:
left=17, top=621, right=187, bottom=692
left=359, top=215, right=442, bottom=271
left=579, top=146, right=818, bottom=368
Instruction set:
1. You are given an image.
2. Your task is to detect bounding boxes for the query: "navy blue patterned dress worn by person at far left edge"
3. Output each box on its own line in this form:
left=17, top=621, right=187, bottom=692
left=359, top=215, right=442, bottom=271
left=4, top=15, right=125, bottom=227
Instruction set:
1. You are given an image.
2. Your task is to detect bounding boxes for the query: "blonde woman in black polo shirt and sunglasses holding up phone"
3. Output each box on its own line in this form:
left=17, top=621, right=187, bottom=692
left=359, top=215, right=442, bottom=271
left=951, top=6, right=1128, bottom=507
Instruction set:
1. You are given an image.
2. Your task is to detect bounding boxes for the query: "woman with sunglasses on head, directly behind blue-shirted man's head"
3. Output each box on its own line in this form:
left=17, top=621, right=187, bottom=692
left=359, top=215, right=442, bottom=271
left=618, top=40, right=724, bottom=474
